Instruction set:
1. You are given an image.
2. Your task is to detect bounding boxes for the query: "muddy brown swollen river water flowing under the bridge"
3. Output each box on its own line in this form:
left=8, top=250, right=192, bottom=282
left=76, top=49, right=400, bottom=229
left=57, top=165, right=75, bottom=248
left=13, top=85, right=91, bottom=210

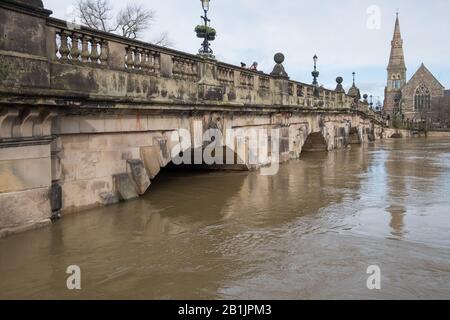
left=0, top=139, right=450, bottom=299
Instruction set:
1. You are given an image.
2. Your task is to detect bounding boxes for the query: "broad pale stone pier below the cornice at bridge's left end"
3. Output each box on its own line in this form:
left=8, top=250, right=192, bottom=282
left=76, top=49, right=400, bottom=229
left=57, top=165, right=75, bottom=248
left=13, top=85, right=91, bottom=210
left=0, top=107, right=57, bottom=237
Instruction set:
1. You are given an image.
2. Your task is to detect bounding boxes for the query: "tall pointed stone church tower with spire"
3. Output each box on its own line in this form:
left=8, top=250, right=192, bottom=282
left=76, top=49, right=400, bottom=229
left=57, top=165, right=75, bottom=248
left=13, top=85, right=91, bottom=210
left=384, top=13, right=406, bottom=114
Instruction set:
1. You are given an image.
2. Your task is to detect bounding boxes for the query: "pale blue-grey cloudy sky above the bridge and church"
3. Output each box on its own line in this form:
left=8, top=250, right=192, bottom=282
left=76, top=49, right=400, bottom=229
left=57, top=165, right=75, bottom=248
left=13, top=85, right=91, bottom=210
left=44, top=0, right=450, bottom=100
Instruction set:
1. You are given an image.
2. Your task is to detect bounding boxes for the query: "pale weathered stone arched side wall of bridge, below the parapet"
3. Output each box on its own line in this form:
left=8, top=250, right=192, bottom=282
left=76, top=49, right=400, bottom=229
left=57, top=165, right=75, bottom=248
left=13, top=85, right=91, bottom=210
left=54, top=113, right=371, bottom=212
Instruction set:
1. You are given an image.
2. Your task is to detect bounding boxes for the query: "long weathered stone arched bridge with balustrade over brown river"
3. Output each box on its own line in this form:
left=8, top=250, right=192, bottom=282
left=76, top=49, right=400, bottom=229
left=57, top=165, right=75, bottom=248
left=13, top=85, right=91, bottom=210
left=0, top=0, right=384, bottom=235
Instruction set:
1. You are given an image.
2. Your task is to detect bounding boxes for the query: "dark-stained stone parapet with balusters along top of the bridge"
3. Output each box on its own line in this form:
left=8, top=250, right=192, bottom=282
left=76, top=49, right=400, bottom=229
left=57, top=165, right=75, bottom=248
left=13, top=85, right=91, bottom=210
left=0, top=0, right=382, bottom=122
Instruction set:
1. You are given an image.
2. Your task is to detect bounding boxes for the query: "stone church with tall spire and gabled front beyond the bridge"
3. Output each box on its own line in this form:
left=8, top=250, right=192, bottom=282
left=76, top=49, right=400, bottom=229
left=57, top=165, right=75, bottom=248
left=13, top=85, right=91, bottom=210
left=384, top=14, right=450, bottom=122
